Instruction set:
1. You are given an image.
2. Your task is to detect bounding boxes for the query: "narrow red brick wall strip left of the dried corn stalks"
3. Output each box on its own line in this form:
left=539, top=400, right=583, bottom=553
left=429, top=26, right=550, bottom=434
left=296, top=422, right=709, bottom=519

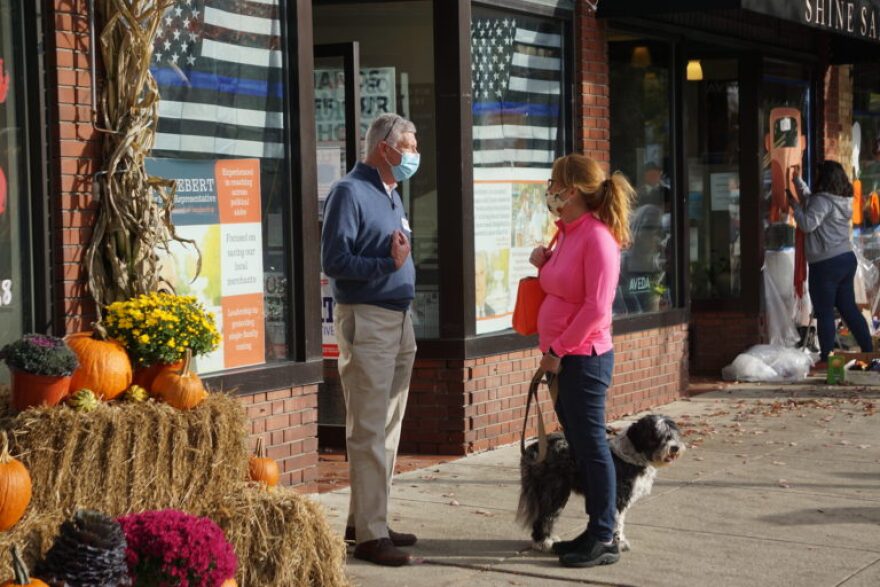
left=52, top=0, right=100, bottom=333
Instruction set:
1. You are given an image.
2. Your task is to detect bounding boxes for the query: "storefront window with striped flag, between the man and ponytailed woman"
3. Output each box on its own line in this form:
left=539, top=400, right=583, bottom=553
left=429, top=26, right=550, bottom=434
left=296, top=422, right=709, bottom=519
left=471, top=6, right=570, bottom=334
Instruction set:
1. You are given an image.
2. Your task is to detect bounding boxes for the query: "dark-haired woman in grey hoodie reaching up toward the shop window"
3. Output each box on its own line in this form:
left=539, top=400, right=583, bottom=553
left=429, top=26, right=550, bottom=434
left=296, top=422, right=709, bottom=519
left=792, top=161, right=874, bottom=363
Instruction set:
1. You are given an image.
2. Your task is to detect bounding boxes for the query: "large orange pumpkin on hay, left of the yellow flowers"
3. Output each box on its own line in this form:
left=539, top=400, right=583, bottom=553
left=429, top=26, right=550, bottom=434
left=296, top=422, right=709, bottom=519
left=65, top=332, right=132, bottom=401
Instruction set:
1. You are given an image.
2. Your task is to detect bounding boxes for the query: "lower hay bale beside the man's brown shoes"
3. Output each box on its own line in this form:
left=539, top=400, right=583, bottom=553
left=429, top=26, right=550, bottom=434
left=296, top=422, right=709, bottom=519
left=210, top=483, right=350, bottom=587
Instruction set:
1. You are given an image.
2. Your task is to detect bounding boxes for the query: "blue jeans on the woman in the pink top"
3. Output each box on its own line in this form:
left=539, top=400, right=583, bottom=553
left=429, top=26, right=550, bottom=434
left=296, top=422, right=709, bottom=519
left=556, top=351, right=617, bottom=542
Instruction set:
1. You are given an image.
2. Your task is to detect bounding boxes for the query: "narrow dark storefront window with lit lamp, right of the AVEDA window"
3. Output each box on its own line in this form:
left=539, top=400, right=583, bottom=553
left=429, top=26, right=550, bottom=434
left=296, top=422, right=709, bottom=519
left=684, top=59, right=742, bottom=301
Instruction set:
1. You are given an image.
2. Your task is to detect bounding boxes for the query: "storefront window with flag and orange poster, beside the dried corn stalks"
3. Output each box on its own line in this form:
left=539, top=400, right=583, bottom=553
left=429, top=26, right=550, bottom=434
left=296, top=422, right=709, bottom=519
left=147, top=0, right=295, bottom=373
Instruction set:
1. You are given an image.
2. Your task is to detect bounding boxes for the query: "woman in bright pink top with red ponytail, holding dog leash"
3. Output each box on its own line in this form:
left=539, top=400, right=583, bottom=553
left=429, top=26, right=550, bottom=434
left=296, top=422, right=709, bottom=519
left=530, top=154, right=635, bottom=567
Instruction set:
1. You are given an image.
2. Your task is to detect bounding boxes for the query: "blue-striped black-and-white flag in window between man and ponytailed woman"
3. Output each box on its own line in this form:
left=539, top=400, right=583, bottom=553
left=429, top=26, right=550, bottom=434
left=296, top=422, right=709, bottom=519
left=471, top=17, right=563, bottom=167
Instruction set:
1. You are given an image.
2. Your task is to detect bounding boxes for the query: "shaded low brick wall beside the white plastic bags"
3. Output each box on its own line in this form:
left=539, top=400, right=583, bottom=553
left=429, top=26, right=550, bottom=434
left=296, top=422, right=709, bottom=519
left=689, top=312, right=764, bottom=377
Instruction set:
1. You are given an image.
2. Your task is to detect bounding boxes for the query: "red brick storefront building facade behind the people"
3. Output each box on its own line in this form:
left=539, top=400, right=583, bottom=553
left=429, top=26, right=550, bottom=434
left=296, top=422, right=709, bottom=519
left=0, top=0, right=880, bottom=491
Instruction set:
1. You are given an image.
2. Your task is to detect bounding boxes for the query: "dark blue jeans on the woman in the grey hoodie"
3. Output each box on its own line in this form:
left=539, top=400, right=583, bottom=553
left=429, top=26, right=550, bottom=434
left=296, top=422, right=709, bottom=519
left=810, top=253, right=874, bottom=361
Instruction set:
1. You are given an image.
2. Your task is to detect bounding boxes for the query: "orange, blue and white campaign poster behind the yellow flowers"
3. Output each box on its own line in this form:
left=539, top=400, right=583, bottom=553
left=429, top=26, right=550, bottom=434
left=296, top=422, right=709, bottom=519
left=147, top=158, right=266, bottom=373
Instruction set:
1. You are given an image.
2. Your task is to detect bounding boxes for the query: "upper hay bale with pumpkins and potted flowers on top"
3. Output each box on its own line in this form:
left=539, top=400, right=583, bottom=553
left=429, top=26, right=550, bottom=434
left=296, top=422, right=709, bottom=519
left=0, top=393, right=248, bottom=516
